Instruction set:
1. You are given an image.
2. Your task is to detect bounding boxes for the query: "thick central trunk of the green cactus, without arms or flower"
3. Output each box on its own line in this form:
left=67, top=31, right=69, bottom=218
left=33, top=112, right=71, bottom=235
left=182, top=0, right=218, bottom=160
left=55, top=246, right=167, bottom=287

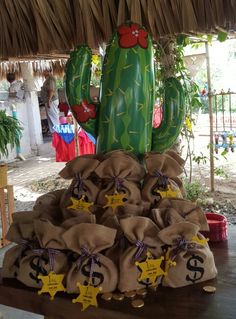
left=97, top=28, right=154, bottom=154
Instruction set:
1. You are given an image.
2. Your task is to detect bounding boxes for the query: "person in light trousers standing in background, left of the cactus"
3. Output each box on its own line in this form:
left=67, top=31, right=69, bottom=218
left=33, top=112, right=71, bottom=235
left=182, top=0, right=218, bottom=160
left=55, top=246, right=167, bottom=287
left=41, top=69, right=59, bottom=133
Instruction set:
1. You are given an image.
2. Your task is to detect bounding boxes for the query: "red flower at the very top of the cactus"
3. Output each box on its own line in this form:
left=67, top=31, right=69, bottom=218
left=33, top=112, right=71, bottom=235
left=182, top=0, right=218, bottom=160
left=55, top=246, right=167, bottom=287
left=118, top=23, right=148, bottom=49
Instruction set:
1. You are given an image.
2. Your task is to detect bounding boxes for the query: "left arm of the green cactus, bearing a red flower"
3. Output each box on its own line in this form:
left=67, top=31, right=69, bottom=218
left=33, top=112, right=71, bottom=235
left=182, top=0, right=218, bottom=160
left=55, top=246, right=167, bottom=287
left=65, top=45, right=97, bottom=138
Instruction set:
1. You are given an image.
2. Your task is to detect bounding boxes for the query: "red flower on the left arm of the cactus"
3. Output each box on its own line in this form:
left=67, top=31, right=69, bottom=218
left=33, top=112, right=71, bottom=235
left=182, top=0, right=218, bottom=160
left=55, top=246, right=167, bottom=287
left=71, top=99, right=96, bottom=123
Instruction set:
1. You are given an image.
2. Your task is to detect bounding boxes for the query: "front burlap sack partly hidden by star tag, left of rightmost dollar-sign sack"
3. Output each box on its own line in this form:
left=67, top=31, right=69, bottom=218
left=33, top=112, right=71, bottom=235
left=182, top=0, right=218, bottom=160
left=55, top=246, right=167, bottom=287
left=118, top=216, right=162, bottom=292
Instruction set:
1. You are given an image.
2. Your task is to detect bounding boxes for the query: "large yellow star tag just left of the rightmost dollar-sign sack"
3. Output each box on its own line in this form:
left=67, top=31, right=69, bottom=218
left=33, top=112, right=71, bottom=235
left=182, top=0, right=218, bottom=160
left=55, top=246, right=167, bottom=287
left=135, top=251, right=165, bottom=284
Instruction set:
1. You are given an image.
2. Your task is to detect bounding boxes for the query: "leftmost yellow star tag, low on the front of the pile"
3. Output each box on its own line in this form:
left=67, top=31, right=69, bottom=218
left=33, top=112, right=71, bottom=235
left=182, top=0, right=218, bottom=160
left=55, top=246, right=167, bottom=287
left=38, top=271, right=66, bottom=300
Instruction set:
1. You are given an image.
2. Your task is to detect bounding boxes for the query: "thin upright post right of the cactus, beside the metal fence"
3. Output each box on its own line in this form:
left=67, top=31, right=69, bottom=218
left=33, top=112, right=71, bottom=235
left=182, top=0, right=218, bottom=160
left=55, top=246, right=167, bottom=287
left=205, top=42, right=215, bottom=192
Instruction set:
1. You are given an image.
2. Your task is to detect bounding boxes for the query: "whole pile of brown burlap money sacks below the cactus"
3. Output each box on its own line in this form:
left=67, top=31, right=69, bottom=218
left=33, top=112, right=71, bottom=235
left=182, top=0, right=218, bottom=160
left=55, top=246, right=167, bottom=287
left=3, top=151, right=217, bottom=293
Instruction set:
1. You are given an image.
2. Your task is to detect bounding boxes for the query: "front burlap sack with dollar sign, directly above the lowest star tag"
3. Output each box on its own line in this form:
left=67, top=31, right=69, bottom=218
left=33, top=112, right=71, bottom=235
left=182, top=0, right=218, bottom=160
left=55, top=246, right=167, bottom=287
left=63, top=223, right=118, bottom=293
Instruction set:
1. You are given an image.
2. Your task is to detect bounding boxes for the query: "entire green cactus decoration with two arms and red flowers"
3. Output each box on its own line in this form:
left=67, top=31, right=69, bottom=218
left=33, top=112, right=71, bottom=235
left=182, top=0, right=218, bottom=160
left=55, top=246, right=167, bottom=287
left=66, top=23, right=184, bottom=155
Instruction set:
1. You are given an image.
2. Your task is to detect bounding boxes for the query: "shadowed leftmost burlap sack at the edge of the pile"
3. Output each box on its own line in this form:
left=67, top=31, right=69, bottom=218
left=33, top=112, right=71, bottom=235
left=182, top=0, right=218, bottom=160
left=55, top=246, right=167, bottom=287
left=3, top=220, right=39, bottom=278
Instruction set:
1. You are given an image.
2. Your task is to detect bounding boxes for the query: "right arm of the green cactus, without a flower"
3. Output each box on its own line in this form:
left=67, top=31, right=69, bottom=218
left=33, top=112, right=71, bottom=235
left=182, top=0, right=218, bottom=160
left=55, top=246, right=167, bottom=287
left=152, top=78, right=185, bottom=153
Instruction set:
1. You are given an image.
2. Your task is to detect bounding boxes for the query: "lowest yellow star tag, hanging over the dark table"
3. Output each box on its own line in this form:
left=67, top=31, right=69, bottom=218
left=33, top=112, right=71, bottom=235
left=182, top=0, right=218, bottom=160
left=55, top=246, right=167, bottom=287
left=72, top=282, right=102, bottom=311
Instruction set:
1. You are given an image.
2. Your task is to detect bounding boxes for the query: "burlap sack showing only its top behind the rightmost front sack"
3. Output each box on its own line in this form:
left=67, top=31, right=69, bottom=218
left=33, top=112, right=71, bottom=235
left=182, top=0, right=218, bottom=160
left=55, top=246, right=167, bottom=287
left=157, top=198, right=209, bottom=231
